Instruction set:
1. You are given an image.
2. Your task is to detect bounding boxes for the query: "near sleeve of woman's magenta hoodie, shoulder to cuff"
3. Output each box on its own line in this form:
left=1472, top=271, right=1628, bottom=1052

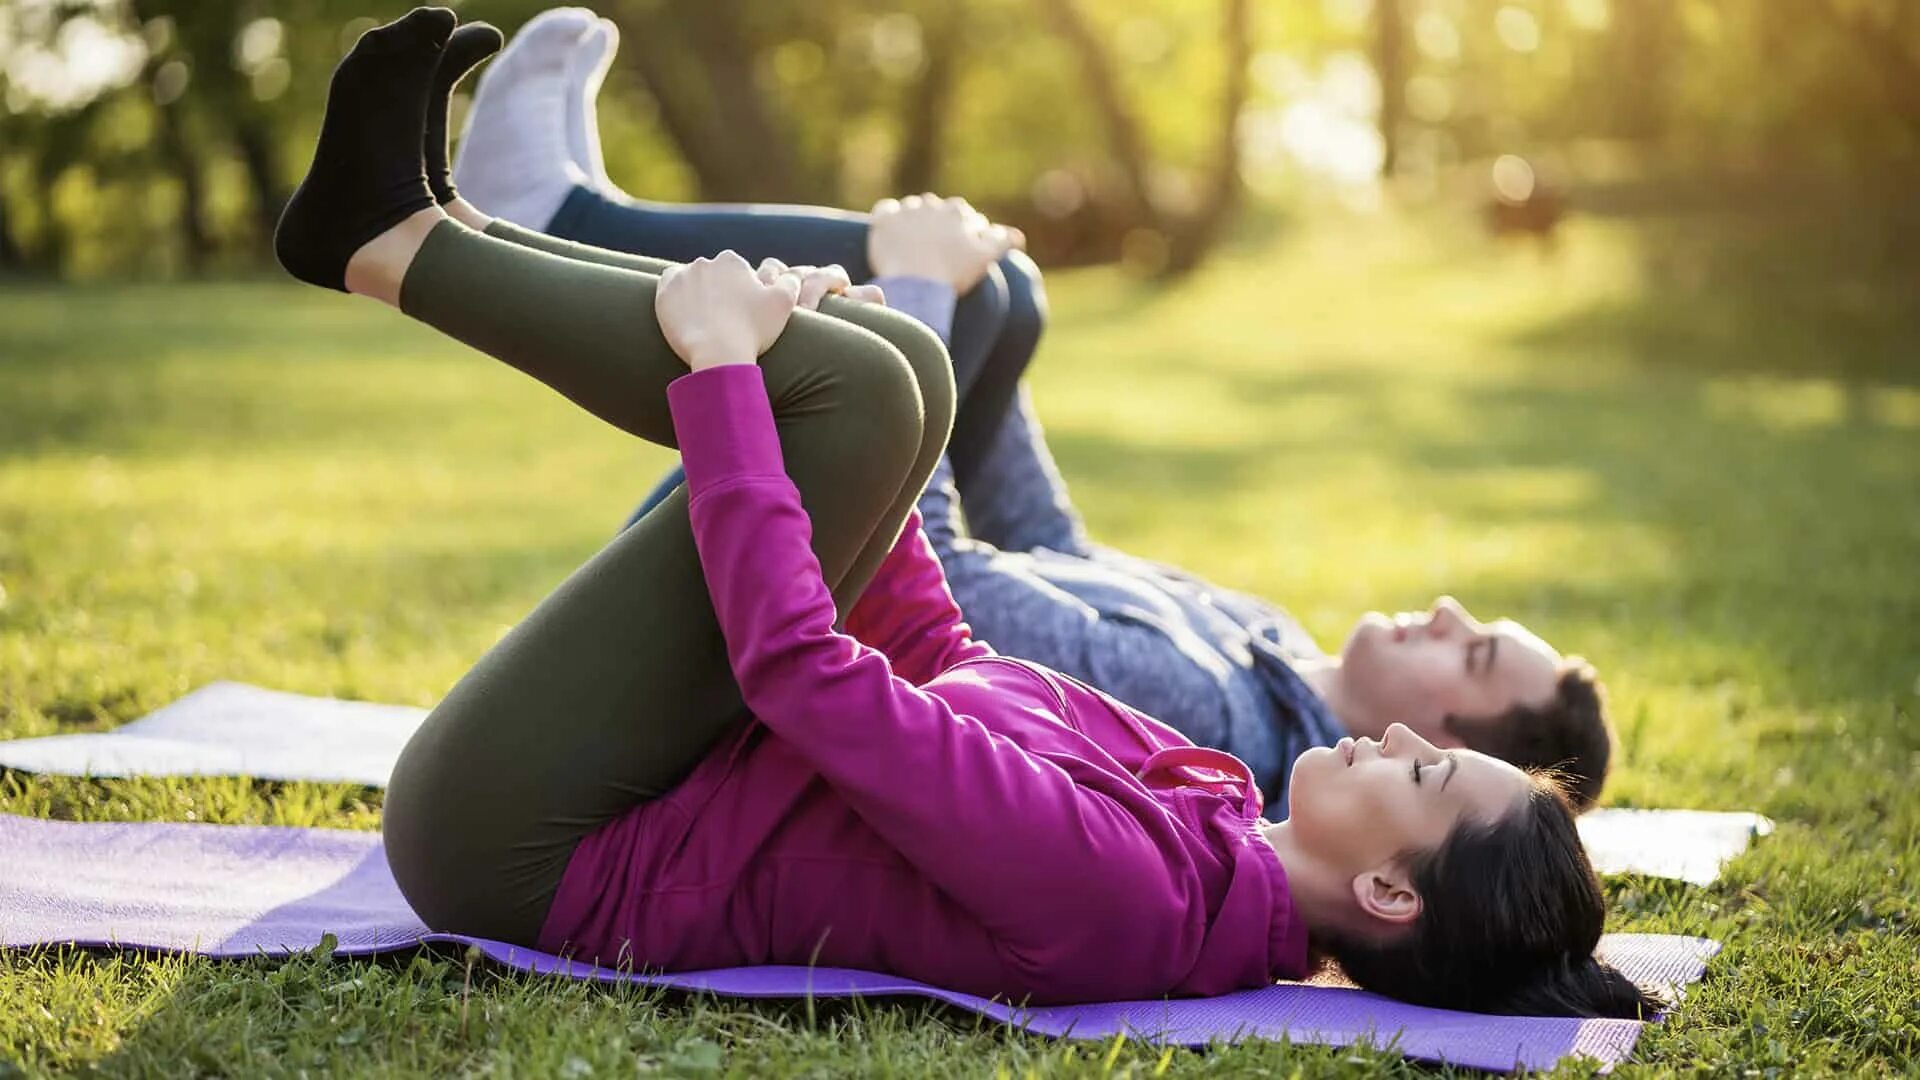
left=668, top=365, right=1204, bottom=963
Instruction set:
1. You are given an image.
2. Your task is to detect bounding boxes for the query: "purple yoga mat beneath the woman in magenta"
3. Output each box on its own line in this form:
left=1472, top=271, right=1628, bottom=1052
left=0, top=815, right=1718, bottom=1070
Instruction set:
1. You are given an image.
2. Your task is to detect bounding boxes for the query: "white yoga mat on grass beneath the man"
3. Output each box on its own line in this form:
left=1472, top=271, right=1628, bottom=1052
left=0, top=682, right=1774, bottom=886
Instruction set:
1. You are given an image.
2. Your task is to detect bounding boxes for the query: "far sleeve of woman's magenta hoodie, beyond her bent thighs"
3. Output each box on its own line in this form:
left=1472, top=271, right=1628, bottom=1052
left=847, top=509, right=993, bottom=686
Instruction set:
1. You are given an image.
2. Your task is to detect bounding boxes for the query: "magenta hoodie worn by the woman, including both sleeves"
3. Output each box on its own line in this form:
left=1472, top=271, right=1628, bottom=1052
left=540, top=365, right=1308, bottom=1003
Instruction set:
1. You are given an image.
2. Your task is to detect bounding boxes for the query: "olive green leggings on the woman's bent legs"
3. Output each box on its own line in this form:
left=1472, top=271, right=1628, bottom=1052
left=384, top=221, right=954, bottom=945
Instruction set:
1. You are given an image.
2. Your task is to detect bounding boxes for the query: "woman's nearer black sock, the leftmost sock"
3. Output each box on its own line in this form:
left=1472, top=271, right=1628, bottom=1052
left=273, top=8, right=455, bottom=292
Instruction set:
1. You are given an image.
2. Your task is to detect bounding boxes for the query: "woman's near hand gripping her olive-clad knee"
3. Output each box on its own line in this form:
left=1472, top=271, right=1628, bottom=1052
left=653, top=252, right=798, bottom=371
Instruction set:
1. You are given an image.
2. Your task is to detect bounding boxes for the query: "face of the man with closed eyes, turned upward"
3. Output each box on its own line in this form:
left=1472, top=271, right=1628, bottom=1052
left=1340, top=596, right=1561, bottom=748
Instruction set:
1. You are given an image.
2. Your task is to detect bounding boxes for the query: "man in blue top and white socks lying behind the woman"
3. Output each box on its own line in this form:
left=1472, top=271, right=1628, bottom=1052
left=441, top=8, right=1613, bottom=817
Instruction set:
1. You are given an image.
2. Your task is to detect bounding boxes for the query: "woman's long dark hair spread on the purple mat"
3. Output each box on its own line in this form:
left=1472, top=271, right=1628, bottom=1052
left=1315, top=774, right=1659, bottom=1019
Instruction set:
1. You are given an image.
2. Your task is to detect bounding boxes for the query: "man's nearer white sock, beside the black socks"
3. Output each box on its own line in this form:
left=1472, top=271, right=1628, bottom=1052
left=453, top=8, right=599, bottom=231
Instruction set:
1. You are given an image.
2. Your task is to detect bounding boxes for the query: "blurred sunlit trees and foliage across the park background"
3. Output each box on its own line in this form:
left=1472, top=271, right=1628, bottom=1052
left=0, top=0, right=1920, bottom=277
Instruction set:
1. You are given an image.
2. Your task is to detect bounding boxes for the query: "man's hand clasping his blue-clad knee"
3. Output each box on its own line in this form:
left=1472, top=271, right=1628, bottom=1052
left=866, top=194, right=1025, bottom=292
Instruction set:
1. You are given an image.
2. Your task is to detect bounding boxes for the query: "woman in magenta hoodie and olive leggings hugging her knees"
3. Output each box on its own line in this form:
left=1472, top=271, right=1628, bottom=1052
left=275, top=8, right=1649, bottom=1015
